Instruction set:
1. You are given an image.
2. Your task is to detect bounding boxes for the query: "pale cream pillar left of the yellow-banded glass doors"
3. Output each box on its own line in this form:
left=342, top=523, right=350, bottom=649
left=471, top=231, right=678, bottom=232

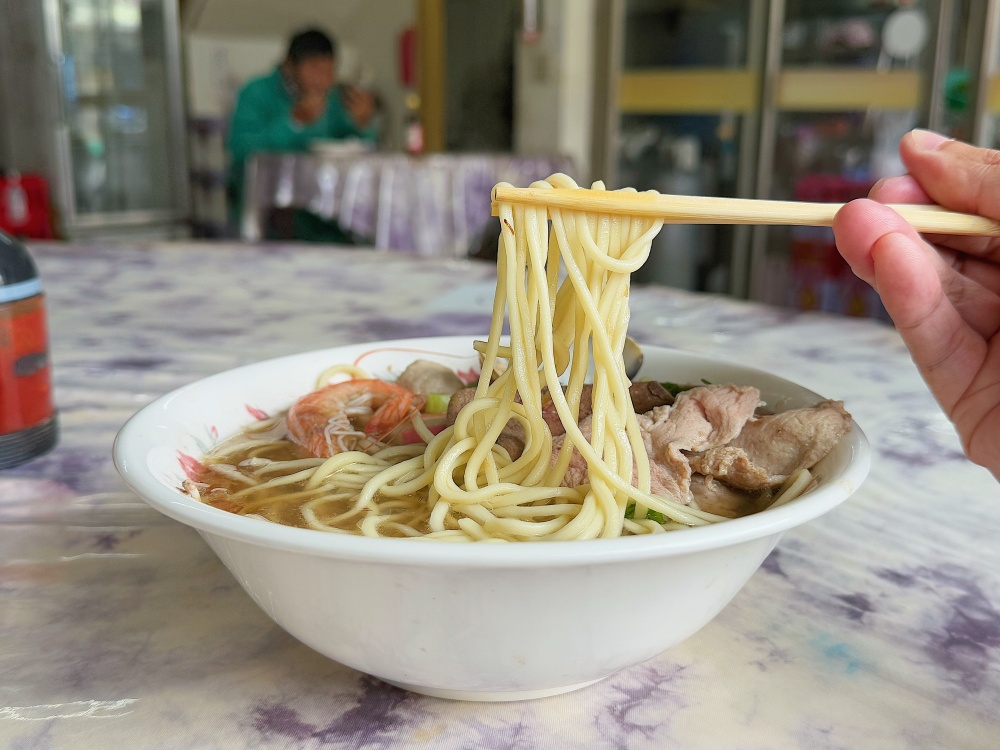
left=514, top=0, right=592, bottom=181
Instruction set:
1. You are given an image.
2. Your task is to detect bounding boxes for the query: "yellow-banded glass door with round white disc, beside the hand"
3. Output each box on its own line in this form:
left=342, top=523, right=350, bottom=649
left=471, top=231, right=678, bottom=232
left=750, top=0, right=965, bottom=317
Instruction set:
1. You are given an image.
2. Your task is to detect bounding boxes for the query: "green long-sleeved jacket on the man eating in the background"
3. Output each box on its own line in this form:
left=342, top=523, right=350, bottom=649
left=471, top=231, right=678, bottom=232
left=228, top=68, right=375, bottom=219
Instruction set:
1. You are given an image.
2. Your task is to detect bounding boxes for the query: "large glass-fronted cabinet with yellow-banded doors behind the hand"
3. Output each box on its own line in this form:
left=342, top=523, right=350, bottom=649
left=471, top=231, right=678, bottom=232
left=595, top=0, right=988, bottom=316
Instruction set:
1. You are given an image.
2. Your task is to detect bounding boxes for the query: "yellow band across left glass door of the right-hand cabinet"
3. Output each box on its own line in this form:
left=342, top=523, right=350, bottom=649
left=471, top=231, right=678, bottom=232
left=618, top=68, right=759, bottom=114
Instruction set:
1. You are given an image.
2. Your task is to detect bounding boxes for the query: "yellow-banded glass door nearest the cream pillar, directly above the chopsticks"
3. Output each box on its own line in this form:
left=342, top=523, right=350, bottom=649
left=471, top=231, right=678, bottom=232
left=609, top=0, right=766, bottom=292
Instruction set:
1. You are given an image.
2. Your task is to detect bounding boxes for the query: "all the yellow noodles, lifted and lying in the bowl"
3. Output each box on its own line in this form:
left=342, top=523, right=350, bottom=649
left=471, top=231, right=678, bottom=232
left=196, top=175, right=824, bottom=542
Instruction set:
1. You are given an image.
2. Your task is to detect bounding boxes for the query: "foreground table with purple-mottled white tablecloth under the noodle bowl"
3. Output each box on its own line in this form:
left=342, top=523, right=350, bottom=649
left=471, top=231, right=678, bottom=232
left=0, top=244, right=1000, bottom=750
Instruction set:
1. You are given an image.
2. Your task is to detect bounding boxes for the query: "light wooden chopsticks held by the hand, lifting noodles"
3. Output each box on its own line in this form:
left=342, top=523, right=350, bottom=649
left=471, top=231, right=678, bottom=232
left=492, top=185, right=1000, bottom=237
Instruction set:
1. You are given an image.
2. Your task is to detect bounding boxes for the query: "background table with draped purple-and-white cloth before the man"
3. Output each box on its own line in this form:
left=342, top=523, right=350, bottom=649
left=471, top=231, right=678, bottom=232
left=240, top=151, right=573, bottom=257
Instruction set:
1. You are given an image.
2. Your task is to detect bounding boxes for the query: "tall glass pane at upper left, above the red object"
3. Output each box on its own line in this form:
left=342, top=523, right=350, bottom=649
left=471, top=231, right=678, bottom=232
left=52, top=0, right=184, bottom=227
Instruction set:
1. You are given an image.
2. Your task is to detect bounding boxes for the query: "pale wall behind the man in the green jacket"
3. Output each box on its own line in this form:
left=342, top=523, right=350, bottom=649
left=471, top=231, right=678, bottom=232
left=183, top=0, right=416, bottom=147
